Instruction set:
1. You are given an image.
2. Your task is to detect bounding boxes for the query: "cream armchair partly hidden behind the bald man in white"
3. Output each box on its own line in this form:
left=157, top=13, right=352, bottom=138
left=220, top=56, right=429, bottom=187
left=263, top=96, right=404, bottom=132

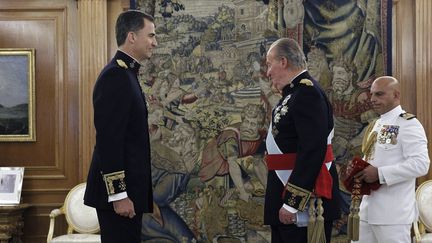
left=413, top=180, right=432, bottom=243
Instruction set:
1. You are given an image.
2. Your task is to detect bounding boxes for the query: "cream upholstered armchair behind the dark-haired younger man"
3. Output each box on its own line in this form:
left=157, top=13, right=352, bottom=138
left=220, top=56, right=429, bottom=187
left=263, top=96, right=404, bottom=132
left=47, top=183, right=101, bottom=243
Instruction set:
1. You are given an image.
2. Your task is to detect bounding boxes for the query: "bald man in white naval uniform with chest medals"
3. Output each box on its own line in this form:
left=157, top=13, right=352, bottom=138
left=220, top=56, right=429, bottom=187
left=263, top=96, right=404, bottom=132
left=355, top=76, right=430, bottom=243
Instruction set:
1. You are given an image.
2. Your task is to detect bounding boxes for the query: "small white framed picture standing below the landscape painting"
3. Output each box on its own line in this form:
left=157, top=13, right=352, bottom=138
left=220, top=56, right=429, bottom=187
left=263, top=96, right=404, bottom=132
left=0, top=167, right=24, bottom=205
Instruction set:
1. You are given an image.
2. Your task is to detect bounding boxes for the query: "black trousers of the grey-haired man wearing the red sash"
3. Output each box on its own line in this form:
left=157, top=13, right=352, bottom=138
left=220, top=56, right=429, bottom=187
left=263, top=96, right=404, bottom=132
left=271, top=221, right=333, bottom=243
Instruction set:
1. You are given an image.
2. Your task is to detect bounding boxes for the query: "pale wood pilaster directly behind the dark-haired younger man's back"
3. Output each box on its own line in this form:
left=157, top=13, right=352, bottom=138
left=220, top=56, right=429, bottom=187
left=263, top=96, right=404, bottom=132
left=78, top=0, right=108, bottom=181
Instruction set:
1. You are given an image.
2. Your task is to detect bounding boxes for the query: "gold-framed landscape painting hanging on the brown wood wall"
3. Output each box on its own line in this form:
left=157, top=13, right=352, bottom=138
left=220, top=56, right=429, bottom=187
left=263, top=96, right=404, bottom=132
left=0, top=48, right=36, bottom=142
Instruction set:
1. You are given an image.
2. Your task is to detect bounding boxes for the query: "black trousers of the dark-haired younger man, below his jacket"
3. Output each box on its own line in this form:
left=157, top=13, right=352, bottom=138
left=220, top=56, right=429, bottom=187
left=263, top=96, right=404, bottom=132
left=96, top=209, right=142, bottom=243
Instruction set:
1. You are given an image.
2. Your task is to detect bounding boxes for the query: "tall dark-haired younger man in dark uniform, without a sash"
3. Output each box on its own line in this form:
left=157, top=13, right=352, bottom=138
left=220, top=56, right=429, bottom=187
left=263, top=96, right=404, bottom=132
left=84, top=10, right=157, bottom=243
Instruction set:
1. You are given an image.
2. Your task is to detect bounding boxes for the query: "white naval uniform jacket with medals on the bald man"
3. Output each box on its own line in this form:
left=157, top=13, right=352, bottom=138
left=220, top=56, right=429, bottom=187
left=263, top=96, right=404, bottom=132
left=360, top=106, right=430, bottom=225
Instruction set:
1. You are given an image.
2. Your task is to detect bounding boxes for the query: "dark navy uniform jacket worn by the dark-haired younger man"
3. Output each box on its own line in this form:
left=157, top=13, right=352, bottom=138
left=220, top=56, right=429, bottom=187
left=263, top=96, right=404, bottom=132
left=84, top=51, right=153, bottom=242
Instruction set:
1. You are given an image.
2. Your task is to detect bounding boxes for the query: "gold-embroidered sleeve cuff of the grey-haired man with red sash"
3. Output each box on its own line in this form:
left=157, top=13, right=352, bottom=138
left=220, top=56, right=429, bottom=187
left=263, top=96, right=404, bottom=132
left=283, top=183, right=312, bottom=211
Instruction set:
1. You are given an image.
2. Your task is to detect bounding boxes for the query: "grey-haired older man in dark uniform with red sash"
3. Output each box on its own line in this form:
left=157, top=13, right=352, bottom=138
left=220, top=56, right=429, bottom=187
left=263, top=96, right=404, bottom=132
left=264, top=38, right=340, bottom=243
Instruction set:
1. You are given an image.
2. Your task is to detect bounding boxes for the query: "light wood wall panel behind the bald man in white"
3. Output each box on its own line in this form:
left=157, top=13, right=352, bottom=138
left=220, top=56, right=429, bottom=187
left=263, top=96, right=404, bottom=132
left=392, top=0, right=432, bottom=183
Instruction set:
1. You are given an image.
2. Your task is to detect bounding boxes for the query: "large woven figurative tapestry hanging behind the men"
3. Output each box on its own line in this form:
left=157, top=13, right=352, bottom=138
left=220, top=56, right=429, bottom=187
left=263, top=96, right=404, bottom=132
left=135, top=0, right=391, bottom=242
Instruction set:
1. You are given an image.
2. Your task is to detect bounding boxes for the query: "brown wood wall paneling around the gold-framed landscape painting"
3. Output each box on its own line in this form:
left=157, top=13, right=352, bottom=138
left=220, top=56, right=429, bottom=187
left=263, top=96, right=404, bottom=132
left=0, top=0, right=79, bottom=243
